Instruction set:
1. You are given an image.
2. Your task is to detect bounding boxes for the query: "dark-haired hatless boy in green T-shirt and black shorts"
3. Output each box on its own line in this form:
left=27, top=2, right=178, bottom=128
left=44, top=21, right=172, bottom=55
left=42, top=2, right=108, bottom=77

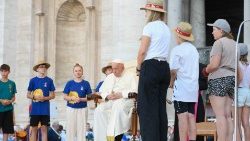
left=0, top=64, right=16, bottom=141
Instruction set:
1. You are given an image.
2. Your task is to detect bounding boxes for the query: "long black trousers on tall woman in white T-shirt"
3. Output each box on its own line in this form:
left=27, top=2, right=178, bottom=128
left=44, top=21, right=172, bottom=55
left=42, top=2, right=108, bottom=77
left=137, top=59, right=170, bottom=141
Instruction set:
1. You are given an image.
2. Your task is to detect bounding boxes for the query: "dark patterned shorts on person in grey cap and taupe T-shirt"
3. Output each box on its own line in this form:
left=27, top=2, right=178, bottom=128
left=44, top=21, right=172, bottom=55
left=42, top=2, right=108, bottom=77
left=207, top=76, right=235, bottom=99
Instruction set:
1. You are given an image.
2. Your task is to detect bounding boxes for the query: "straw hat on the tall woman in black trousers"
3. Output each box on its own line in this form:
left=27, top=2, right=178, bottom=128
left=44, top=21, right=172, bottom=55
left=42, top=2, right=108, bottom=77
left=140, top=0, right=166, bottom=13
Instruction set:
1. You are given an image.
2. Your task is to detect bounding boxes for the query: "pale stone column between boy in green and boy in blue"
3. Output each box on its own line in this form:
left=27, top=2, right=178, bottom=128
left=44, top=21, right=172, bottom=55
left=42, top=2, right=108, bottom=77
left=15, top=0, right=33, bottom=124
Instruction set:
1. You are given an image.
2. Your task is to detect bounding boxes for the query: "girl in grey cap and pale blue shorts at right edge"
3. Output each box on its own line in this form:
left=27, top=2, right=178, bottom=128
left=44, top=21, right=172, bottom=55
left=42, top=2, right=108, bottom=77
left=236, top=43, right=250, bottom=141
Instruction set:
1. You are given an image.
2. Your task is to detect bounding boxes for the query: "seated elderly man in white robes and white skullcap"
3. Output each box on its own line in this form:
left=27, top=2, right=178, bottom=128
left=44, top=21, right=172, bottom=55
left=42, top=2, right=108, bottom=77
left=94, top=59, right=138, bottom=141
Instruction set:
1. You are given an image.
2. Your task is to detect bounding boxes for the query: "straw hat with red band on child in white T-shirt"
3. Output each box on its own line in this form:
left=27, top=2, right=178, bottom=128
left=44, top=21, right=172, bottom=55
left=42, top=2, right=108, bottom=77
left=174, top=22, right=194, bottom=42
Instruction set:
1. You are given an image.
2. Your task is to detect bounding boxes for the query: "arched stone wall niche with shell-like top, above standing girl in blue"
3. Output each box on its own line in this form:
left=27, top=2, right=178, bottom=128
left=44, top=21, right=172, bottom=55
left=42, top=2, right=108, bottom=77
left=55, top=0, right=87, bottom=88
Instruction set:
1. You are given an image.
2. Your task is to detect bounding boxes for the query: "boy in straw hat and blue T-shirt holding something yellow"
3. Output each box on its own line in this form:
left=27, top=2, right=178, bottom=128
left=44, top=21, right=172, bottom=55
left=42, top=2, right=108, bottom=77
left=27, top=61, right=55, bottom=141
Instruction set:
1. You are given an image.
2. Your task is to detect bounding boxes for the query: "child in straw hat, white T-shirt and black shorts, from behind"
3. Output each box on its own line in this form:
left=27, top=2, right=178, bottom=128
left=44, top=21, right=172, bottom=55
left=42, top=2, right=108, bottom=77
left=169, top=22, right=199, bottom=141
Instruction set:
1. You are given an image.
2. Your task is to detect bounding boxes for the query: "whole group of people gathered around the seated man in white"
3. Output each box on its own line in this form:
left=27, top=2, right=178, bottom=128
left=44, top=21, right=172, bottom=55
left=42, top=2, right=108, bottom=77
left=0, top=0, right=250, bottom=141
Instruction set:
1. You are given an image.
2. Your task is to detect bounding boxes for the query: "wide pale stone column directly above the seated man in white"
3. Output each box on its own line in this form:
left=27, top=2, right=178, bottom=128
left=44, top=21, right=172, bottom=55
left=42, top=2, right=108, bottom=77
left=112, top=0, right=146, bottom=61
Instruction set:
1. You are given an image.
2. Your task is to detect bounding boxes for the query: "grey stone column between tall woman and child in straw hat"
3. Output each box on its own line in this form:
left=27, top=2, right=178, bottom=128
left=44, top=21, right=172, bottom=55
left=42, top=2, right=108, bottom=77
left=167, top=0, right=183, bottom=53
